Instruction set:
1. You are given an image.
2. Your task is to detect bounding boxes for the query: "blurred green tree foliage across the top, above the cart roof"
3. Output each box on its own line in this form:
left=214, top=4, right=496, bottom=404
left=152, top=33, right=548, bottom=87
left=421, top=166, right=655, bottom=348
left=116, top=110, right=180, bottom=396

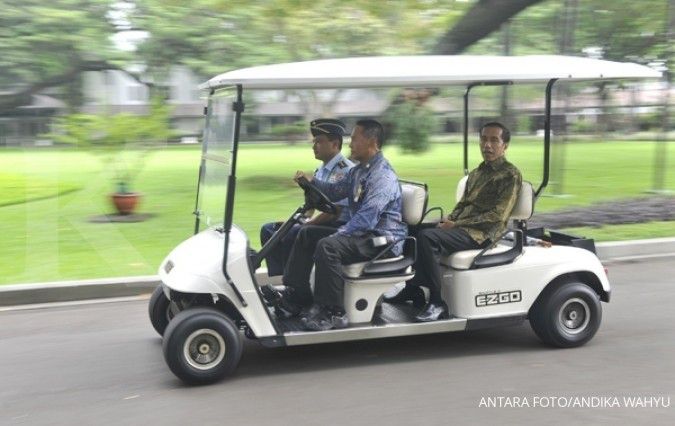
left=0, top=0, right=668, bottom=114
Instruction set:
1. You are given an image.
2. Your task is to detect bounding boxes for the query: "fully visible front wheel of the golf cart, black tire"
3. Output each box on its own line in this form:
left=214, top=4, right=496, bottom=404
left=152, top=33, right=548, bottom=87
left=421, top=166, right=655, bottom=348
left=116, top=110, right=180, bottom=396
left=163, top=308, right=243, bottom=384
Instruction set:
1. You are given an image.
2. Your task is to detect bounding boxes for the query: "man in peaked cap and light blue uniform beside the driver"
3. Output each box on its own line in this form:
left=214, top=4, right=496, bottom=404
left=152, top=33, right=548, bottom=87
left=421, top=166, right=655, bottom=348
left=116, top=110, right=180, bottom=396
left=260, top=118, right=354, bottom=277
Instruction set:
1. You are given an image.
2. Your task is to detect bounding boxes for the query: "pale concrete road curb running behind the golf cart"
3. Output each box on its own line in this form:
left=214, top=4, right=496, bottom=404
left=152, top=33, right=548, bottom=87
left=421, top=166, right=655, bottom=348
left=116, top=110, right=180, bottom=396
left=0, top=238, right=675, bottom=306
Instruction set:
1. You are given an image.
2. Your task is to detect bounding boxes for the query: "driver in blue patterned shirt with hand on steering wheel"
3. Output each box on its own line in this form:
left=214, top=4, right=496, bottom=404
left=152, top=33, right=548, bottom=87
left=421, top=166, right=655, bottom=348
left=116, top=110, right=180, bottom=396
left=277, top=120, right=408, bottom=331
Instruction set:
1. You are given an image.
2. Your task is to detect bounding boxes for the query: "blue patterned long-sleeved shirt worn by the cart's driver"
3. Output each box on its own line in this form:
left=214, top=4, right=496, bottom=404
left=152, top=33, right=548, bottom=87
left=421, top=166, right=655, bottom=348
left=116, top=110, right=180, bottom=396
left=316, top=152, right=408, bottom=255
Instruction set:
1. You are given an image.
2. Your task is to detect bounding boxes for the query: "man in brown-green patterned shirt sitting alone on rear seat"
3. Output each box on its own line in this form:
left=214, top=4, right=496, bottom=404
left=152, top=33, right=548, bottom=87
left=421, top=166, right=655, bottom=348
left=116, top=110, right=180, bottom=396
left=384, top=122, right=522, bottom=322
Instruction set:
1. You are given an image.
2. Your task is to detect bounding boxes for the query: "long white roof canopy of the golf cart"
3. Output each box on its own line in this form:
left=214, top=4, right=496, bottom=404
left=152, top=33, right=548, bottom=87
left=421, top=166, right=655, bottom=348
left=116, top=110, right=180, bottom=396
left=200, top=55, right=661, bottom=89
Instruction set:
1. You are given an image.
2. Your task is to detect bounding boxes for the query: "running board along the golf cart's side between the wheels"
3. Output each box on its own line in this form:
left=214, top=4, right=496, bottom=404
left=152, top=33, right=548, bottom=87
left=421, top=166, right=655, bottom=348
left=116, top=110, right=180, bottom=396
left=283, top=318, right=466, bottom=346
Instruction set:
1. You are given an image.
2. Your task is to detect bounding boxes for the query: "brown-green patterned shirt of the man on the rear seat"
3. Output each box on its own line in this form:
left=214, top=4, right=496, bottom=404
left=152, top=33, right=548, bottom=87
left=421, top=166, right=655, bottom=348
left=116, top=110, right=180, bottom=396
left=449, top=157, right=523, bottom=244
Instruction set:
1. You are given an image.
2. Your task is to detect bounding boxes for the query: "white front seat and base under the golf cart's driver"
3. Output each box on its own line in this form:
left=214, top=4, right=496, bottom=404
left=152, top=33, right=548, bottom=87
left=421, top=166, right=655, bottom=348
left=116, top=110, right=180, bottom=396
left=342, top=181, right=429, bottom=323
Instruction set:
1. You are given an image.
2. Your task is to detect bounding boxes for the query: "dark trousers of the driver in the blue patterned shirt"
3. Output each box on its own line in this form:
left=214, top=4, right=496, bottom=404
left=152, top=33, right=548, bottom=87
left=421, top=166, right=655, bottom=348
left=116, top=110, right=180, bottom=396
left=283, top=225, right=381, bottom=307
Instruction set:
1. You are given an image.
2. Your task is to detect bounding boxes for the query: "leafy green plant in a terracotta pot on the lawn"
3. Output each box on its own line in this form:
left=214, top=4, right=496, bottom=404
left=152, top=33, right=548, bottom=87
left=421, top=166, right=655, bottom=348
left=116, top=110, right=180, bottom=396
left=50, top=99, right=171, bottom=215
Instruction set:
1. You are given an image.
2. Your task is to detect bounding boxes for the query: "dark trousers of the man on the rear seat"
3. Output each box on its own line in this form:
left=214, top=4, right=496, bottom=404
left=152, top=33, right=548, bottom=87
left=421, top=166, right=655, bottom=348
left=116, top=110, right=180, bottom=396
left=408, top=228, right=487, bottom=303
